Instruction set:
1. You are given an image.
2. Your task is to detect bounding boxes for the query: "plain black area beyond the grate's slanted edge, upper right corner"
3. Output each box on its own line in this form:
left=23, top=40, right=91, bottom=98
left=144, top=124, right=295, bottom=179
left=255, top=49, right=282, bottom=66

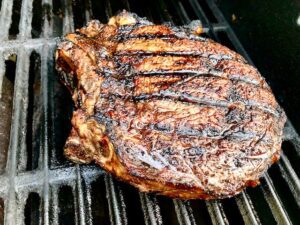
left=219, top=0, right=300, bottom=133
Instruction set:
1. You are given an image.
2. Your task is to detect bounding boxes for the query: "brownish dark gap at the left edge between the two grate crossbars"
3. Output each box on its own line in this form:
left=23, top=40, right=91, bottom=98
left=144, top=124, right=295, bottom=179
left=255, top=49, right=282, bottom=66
left=0, top=55, right=17, bottom=173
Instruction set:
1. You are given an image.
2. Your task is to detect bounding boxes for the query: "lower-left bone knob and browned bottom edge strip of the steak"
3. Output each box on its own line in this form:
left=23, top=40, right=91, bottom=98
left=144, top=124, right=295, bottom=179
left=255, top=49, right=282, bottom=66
left=64, top=110, right=211, bottom=199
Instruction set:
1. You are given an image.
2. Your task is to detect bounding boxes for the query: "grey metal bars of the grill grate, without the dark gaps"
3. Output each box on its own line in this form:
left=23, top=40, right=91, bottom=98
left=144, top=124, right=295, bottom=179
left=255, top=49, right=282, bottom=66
left=0, top=0, right=300, bottom=225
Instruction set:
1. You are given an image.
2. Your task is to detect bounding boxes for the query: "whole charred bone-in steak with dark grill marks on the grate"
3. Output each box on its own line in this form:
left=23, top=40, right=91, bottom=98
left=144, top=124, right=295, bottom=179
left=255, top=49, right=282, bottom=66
left=56, top=11, right=286, bottom=199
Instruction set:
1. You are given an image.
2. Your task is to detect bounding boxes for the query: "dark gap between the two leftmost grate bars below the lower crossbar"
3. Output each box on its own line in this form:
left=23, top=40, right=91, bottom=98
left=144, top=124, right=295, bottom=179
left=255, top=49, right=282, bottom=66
left=24, top=192, right=43, bottom=225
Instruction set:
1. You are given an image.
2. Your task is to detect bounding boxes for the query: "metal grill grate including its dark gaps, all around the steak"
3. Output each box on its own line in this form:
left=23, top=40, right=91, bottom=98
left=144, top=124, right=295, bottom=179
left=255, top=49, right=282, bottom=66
left=0, top=0, right=300, bottom=225
